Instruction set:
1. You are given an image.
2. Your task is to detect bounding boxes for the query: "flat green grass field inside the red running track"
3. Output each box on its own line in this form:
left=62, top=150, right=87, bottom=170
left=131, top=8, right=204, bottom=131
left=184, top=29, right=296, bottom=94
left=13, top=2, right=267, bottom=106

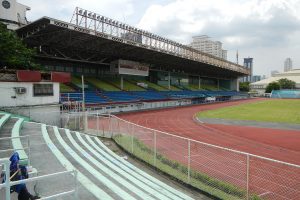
left=197, top=100, right=300, bottom=124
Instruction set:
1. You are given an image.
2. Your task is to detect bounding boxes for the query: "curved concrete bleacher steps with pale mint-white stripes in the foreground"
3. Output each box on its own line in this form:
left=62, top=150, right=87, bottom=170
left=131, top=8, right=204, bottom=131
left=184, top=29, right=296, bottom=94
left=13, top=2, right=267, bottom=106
left=0, top=114, right=192, bottom=200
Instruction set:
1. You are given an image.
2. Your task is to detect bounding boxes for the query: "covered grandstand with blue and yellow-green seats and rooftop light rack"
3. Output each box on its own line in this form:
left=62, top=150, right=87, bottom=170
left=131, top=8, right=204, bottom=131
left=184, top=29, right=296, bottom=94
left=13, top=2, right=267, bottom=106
left=11, top=8, right=249, bottom=111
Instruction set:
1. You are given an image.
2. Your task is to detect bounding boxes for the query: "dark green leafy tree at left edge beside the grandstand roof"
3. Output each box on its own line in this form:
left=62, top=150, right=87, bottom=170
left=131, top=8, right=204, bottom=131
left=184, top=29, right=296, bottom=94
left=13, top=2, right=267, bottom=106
left=0, top=23, right=39, bottom=69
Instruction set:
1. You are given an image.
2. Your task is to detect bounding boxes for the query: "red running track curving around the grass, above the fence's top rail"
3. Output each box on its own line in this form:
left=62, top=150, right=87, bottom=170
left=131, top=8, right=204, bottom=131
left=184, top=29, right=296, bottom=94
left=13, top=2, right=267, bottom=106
left=118, top=99, right=300, bottom=165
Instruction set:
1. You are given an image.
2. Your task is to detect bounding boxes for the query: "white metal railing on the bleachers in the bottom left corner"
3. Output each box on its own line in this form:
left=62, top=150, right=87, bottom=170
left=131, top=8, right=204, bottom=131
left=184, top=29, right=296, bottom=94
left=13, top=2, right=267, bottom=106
left=0, top=158, right=78, bottom=200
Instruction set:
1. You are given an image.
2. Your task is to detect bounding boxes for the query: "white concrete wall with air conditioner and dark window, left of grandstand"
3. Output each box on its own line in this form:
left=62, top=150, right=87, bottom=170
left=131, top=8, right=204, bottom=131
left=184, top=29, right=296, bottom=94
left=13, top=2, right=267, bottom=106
left=0, top=82, right=59, bottom=107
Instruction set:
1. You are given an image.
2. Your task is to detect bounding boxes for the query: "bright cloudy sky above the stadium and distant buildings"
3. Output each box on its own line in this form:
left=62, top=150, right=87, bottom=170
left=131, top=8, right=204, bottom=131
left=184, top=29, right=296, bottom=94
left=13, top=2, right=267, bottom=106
left=18, top=0, right=300, bottom=76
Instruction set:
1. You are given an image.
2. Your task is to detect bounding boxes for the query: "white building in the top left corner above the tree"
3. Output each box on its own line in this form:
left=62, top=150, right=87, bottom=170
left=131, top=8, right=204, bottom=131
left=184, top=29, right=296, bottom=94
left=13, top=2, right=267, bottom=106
left=0, top=0, right=30, bottom=30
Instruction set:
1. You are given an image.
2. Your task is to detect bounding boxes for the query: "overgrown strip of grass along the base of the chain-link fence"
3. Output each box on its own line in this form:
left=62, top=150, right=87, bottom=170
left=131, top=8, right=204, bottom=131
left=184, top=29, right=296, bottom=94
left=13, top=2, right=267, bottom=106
left=113, top=135, right=261, bottom=199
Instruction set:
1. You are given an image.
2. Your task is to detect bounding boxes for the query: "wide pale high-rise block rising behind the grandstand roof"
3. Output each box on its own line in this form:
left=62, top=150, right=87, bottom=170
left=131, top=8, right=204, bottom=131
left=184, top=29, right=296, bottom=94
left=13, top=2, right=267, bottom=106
left=190, top=35, right=227, bottom=60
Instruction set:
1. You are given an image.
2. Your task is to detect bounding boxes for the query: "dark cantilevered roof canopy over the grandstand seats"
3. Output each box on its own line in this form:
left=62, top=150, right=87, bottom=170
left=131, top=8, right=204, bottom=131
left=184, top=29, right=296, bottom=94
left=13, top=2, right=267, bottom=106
left=17, top=17, right=249, bottom=78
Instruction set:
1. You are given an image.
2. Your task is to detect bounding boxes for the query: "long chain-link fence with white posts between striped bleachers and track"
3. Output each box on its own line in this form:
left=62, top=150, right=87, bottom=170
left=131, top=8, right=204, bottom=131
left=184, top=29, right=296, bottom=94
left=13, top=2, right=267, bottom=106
left=87, top=115, right=300, bottom=200
